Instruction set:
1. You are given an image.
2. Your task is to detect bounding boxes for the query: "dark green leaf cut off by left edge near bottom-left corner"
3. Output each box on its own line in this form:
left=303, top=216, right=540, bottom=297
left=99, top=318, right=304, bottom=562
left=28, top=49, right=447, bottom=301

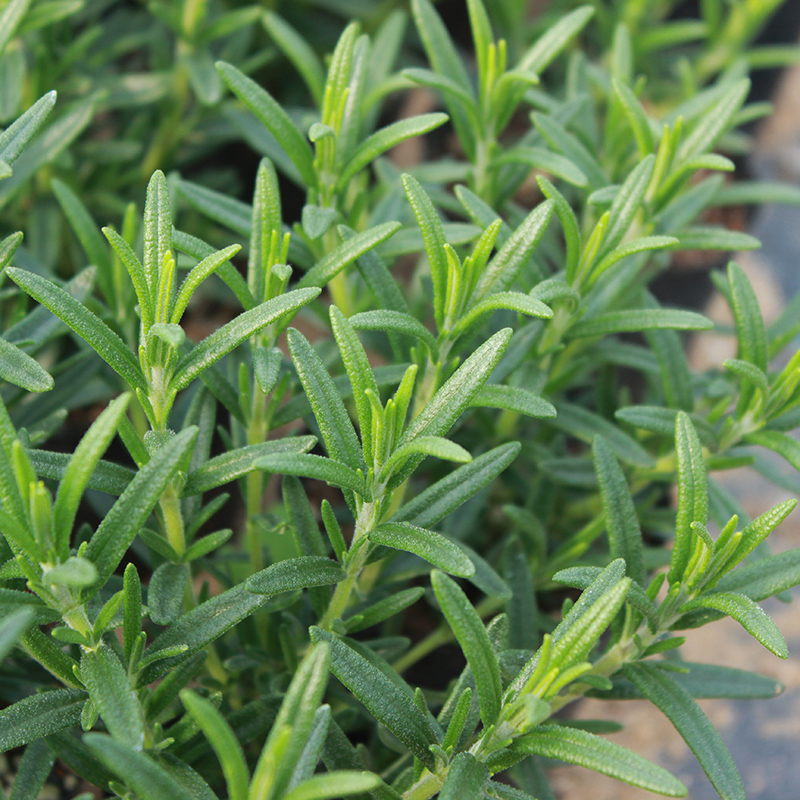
left=0, top=689, right=86, bottom=753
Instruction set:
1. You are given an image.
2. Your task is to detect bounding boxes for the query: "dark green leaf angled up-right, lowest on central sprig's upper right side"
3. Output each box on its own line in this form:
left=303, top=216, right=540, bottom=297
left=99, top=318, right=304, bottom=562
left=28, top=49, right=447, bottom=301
left=392, top=442, right=520, bottom=527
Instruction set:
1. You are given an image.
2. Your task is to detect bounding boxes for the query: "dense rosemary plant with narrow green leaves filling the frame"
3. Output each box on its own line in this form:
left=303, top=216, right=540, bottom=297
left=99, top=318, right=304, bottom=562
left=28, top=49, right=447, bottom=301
left=0, top=0, right=800, bottom=800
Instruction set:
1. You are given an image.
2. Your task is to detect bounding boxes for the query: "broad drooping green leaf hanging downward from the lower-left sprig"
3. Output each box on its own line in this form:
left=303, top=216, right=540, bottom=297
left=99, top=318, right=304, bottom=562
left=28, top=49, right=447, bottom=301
left=80, top=644, right=144, bottom=750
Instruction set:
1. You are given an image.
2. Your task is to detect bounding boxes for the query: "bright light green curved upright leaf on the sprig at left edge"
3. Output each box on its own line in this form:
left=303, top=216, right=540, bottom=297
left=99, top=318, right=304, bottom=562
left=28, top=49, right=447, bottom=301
left=53, top=394, right=130, bottom=558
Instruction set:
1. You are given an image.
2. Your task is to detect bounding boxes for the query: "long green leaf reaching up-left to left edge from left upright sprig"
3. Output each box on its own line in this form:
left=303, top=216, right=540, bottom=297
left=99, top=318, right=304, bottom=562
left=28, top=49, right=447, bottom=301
left=6, top=267, right=147, bottom=391
